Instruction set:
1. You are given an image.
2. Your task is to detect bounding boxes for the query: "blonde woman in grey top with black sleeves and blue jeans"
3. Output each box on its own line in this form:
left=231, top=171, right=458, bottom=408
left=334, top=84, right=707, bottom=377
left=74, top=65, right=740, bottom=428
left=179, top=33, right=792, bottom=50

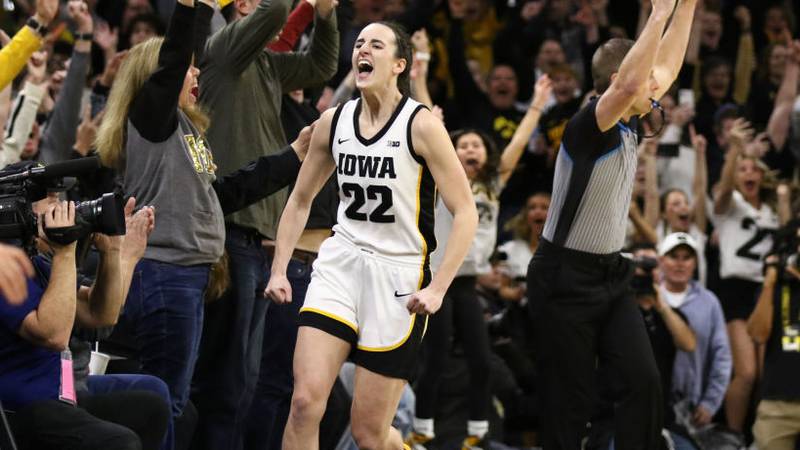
left=96, top=0, right=311, bottom=417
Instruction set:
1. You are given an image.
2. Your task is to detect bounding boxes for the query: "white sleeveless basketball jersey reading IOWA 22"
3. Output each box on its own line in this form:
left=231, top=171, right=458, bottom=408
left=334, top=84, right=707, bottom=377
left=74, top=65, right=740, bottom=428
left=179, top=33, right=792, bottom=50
left=330, top=97, right=436, bottom=268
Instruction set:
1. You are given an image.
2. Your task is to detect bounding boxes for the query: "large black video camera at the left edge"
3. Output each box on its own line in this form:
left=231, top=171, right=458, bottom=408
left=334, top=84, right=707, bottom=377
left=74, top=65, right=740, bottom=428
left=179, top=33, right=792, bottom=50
left=0, top=158, right=125, bottom=254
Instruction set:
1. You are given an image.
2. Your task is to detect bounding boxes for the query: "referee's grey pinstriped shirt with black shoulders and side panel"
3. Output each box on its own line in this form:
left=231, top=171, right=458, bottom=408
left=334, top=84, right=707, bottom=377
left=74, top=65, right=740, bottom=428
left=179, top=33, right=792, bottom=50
left=542, top=99, right=638, bottom=254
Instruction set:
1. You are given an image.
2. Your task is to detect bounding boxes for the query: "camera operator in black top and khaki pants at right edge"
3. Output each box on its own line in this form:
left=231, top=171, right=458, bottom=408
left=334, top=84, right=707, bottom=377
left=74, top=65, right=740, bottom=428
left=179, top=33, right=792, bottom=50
left=747, top=222, right=800, bottom=450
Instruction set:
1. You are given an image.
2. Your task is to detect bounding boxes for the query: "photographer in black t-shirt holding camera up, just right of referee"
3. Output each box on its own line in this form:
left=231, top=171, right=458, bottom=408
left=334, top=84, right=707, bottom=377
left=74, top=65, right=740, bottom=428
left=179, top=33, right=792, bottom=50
left=592, top=241, right=696, bottom=449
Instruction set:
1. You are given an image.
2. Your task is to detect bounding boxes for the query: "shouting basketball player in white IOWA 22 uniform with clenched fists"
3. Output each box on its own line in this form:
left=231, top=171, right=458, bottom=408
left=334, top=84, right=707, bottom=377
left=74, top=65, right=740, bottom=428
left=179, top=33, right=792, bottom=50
left=266, top=23, right=478, bottom=450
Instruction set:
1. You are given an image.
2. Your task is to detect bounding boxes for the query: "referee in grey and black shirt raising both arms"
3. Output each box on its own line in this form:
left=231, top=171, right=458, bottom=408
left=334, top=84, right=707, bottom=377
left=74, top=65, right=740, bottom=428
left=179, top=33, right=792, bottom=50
left=528, top=0, right=697, bottom=450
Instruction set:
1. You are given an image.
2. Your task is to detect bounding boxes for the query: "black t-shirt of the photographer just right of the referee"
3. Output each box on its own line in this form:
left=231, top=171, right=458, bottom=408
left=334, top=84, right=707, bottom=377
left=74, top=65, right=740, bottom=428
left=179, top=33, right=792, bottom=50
left=639, top=308, right=688, bottom=425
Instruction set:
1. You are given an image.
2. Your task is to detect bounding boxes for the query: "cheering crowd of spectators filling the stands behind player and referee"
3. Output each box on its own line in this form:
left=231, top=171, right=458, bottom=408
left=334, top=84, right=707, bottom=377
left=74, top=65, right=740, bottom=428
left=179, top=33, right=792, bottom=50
left=0, top=0, right=800, bottom=450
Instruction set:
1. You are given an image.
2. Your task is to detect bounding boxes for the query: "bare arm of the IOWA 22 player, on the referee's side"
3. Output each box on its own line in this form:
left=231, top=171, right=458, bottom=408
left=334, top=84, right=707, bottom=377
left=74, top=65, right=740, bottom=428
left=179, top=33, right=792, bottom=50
left=408, top=109, right=478, bottom=314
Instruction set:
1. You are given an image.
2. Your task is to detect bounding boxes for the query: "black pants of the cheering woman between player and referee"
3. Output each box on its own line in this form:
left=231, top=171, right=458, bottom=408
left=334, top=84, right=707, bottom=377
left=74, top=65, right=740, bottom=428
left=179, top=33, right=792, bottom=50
left=416, top=276, right=490, bottom=420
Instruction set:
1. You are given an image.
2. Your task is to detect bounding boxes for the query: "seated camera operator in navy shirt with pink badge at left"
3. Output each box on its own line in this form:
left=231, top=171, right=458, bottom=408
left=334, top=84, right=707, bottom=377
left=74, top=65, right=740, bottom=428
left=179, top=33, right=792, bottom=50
left=0, top=198, right=169, bottom=449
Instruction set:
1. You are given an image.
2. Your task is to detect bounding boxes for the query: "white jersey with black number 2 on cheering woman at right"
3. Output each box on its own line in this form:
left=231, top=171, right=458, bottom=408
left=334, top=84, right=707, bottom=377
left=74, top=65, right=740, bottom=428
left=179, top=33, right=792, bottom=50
left=713, top=191, right=778, bottom=282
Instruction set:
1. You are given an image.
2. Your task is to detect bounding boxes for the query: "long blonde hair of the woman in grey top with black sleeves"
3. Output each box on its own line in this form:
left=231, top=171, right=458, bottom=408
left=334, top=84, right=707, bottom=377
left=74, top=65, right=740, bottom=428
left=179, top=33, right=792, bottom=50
left=94, top=38, right=209, bottom=170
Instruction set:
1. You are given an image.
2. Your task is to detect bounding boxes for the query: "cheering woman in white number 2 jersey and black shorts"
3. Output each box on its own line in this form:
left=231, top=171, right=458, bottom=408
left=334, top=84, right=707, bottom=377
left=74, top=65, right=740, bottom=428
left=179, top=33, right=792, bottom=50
left=712, top=119, right=779, bottom=433
